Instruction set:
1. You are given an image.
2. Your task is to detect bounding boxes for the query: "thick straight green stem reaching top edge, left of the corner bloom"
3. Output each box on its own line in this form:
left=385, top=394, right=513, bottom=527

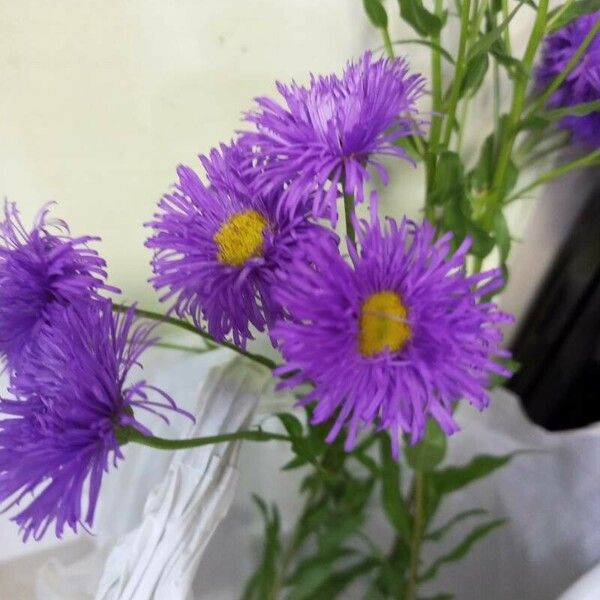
left=483, top=0, right=549, bottom=229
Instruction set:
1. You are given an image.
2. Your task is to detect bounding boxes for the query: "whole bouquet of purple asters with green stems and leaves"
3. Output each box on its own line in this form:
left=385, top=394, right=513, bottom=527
left=0, top=0, right=600, bottom=600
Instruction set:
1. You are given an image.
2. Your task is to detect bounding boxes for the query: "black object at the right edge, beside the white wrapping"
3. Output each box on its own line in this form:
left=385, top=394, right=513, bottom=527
left=508, top=188, right=600, bottom=430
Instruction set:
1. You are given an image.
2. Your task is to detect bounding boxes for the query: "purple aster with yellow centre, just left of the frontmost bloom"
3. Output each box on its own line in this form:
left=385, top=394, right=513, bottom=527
left=146, top=145, right=333, bottom=346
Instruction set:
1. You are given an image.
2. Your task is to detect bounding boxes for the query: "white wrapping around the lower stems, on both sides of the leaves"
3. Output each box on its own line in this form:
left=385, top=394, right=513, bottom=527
left=0, top=352, right=600, bottom=600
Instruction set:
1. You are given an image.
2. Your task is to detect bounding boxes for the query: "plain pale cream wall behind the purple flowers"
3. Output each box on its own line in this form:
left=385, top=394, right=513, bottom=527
left=0, top=0, right=596, bottom=596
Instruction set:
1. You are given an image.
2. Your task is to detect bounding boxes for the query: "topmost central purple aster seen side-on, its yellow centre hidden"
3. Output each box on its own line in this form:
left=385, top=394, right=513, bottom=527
left=241, top=52, right=425, bottom=224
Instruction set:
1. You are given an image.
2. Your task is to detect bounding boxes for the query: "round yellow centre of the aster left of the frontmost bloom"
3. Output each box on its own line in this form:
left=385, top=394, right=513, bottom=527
left=214, top=210, right=268, bottom=267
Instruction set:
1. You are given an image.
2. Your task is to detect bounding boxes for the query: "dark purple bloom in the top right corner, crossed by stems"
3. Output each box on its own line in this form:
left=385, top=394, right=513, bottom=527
left=536, top=11, right=600, bottom=148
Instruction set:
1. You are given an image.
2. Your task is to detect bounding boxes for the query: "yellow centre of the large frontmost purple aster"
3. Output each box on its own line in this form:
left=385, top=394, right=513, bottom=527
left=358, top=292, right=412, bottom=357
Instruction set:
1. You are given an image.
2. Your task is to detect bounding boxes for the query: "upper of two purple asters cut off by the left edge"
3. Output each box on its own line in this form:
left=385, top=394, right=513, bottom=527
left=0, top=202, right=118, bottom=368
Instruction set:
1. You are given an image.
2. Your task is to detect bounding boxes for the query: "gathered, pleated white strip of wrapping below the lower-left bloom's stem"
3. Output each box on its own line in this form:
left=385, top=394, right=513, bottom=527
left=37, top=352, right=282, bottom=600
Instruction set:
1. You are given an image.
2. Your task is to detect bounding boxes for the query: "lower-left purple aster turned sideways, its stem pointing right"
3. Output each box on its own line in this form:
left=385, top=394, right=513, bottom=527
left=0, top=301, right=188, bottom=539
